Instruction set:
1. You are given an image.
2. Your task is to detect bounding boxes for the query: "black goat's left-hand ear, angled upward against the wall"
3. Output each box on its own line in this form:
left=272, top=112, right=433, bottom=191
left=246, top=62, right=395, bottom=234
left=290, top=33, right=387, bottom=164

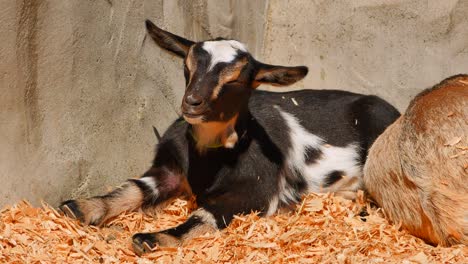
left=146, top=20, right=194, bottom=57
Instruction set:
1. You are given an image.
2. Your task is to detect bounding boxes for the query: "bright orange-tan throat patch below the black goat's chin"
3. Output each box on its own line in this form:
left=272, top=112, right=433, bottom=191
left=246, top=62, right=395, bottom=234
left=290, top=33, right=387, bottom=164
left=192, top=114, right=239, bottom=153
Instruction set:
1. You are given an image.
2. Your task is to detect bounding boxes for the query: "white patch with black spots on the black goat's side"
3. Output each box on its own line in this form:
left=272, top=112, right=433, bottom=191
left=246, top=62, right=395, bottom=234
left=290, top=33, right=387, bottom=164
left=275, top=106, right=362, bottom=196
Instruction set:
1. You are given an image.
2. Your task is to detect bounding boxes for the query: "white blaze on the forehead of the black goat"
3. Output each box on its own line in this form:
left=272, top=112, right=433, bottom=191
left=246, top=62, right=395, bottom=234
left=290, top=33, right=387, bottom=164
left=203, top=40, right=247, bottom=71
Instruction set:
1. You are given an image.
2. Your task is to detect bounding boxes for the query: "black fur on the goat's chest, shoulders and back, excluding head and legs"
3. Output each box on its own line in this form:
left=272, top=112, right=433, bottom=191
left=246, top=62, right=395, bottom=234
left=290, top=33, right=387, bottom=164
left=145, top=90, right=398, bottom=228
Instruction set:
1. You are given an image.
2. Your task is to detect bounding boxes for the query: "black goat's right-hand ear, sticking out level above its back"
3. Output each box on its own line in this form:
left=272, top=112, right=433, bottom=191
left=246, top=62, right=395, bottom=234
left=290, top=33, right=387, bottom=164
left=254, top=63, right=309, bottom=87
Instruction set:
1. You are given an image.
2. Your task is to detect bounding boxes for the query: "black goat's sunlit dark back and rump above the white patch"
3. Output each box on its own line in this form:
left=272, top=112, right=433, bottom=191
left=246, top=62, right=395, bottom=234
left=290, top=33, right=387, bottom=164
left=249, top=90, right=400, bottom=154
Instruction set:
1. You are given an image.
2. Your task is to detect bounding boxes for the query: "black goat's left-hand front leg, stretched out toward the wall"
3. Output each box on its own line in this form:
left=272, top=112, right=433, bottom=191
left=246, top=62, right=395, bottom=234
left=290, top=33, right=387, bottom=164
left=59, top=167, right=189, bottom=225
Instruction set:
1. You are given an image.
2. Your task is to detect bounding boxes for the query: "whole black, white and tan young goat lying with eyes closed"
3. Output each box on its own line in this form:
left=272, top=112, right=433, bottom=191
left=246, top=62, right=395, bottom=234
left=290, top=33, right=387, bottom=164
left=61, top=21, right=399, bottom=254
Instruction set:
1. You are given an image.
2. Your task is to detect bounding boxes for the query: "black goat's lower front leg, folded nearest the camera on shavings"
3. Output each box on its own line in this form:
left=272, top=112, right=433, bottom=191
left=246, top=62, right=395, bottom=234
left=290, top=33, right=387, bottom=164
left=132, top=192, right=266, bottom=255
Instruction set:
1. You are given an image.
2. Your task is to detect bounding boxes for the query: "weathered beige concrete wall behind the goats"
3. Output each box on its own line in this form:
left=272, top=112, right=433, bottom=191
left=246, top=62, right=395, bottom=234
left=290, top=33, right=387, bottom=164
left=0, top=0, right=468, bottom=206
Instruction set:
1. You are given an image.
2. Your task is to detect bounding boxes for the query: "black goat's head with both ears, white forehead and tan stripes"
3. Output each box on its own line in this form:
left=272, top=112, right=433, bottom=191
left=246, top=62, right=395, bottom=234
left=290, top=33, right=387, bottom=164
left=146, top=20, right=308, bottom=124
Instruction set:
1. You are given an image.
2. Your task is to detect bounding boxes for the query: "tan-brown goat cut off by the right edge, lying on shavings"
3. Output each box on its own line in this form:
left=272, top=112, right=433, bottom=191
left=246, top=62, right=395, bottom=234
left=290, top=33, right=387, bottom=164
left=364, top=75, right=468, bottom=246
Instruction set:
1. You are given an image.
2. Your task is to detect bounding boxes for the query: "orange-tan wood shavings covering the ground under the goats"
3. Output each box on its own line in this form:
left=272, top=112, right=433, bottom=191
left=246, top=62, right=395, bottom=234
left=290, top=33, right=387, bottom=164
left=0, top=194, right=468, bottom=263
